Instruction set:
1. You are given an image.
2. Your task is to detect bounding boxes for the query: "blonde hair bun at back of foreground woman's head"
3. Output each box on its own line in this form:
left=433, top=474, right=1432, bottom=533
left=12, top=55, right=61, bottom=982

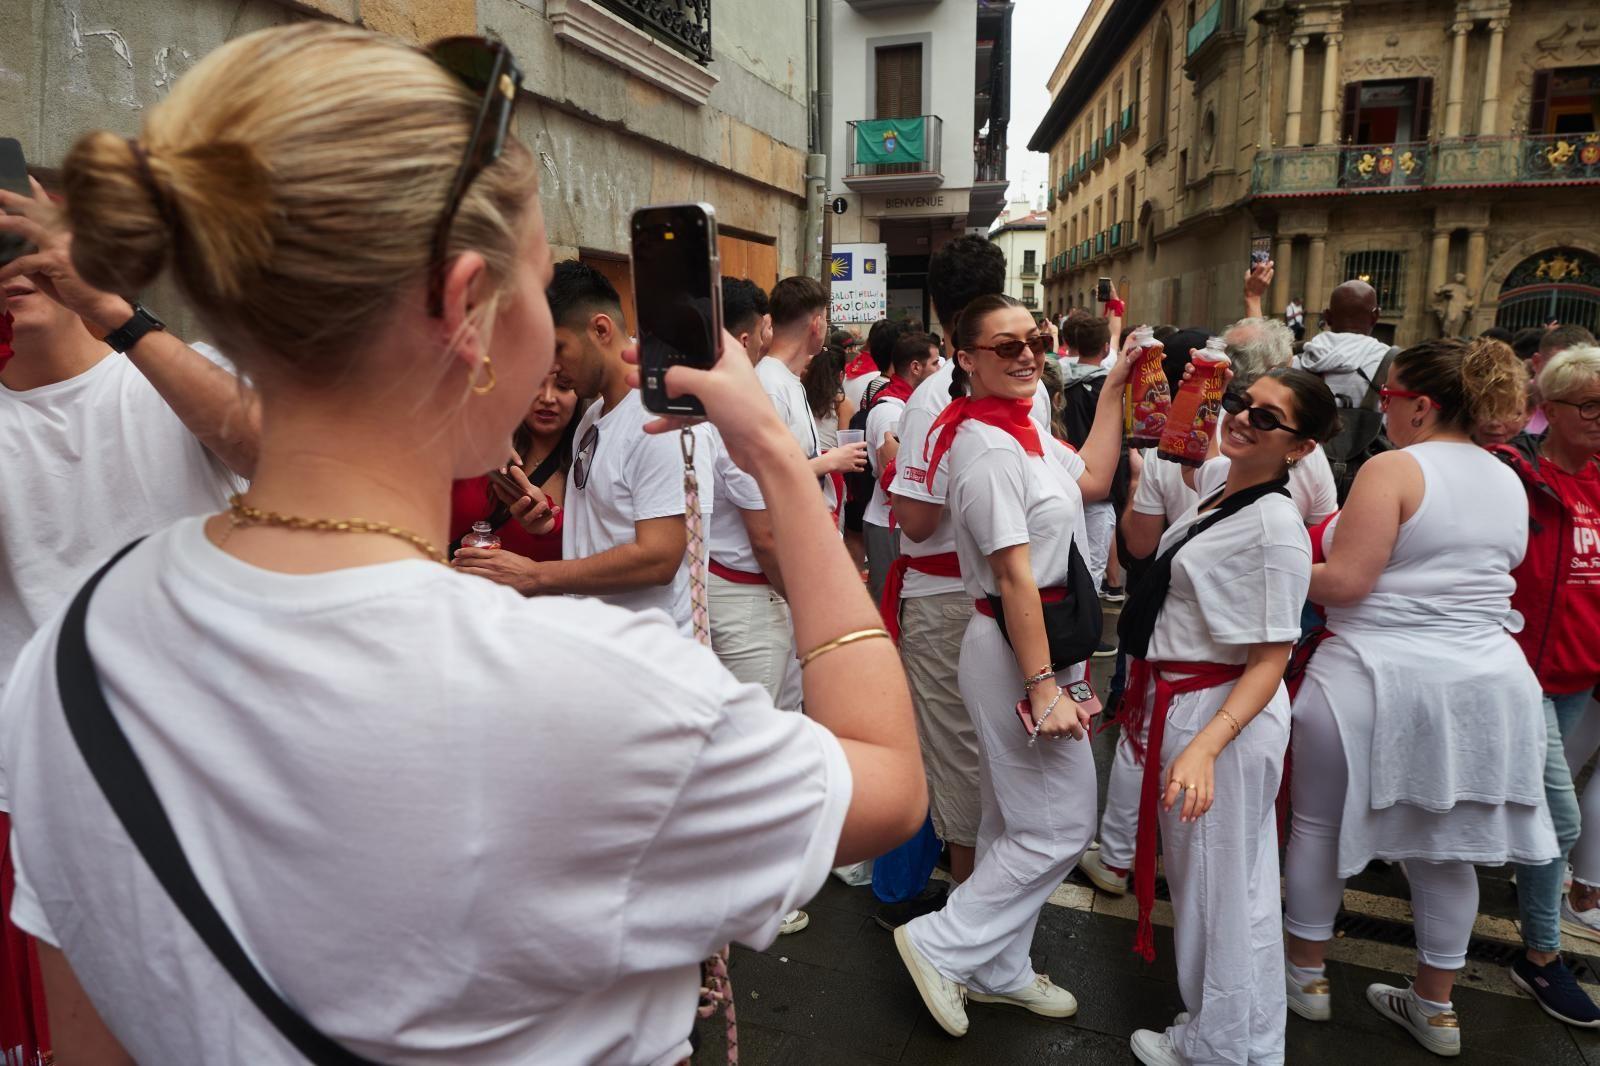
left=62, top=130, right=272, bottom=299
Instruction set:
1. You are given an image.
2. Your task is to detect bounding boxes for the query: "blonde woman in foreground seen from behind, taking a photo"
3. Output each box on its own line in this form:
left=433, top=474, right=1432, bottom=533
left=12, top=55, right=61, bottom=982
left=0, top=22, right=926, bottom=1066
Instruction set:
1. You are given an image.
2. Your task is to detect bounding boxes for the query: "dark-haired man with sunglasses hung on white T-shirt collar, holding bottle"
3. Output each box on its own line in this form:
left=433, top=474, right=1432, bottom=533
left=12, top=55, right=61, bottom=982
left=454, top=259, right=715, bottom=634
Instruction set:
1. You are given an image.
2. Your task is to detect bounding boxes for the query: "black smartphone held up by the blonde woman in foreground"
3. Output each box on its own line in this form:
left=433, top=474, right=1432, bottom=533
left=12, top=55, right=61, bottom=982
left=634, top=203, right=722, bottom=416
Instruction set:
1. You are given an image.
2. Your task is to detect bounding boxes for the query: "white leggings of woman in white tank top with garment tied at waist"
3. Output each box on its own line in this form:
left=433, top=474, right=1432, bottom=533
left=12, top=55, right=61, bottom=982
left=1280, top=693, right=1478, bottom=970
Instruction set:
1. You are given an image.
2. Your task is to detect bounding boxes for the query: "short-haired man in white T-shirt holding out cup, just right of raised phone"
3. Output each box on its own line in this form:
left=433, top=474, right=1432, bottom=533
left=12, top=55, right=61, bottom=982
left=755, top=277, right=867, bottom=477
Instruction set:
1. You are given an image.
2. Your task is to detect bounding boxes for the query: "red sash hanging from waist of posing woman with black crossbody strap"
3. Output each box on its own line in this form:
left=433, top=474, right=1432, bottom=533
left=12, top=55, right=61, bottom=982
left=1122, top=659, right=1245, bottom=962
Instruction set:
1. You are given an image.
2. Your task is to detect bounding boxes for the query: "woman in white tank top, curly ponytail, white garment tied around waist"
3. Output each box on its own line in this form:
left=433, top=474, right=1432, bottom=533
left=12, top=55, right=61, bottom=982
left=1285, top=339, right=1557, bottom=1055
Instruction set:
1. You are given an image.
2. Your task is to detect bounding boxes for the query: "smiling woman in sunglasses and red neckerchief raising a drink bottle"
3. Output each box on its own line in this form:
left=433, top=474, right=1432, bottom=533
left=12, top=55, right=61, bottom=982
left=894, top=295, right=1128, bottom=1036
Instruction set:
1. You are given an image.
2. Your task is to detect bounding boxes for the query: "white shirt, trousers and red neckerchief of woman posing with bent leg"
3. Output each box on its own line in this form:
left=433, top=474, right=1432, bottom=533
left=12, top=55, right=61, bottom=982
left=906, top=399, right=1094, bottom=994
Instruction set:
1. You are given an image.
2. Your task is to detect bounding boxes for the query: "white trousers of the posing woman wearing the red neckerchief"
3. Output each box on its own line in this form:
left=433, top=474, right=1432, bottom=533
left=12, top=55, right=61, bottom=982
left=906, top=615, right=1094, bottom=994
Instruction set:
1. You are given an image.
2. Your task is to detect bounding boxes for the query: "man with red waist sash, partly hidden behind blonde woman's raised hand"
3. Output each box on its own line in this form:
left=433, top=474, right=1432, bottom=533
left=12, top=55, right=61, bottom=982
left=706, top=277, right=800, bottom=711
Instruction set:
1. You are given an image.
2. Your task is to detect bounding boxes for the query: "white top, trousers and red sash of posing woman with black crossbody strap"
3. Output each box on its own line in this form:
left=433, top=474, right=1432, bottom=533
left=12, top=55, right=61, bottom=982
left=1128, top=464, right=1310, bottom=1066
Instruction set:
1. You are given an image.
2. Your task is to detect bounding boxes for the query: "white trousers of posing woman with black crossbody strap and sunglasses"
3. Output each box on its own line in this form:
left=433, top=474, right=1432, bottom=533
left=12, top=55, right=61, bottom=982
left=1158, top=685, right=1290, bottom=1066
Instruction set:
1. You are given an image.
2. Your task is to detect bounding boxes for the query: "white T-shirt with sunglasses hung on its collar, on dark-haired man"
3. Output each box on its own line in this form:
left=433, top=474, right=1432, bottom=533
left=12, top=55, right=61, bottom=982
left=562, top=389, right=717, bottom=634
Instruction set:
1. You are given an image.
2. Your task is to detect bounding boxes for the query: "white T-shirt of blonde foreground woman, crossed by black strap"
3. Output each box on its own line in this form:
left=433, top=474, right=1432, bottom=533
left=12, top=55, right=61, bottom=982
left=0, top=519, right=851, bottom=1066
